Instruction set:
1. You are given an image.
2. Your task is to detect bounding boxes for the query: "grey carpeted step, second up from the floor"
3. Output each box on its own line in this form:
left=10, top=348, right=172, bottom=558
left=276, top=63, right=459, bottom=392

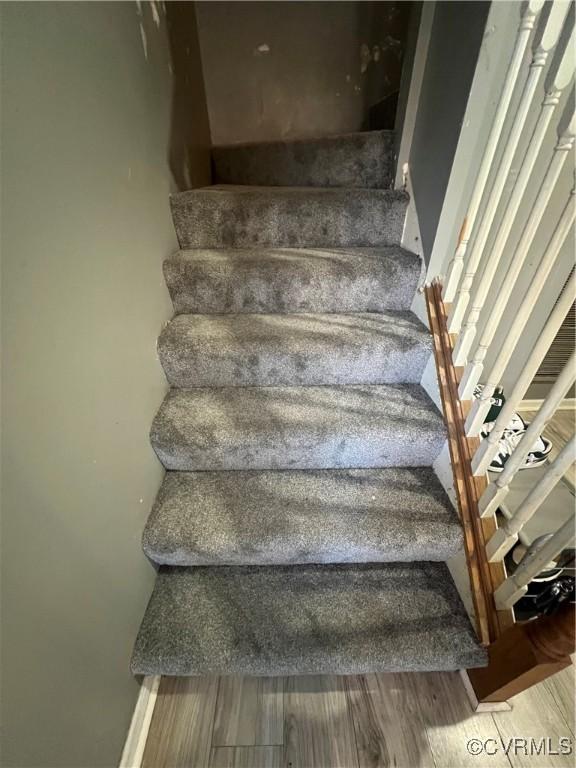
left=143, top=467, right=462, bottom=565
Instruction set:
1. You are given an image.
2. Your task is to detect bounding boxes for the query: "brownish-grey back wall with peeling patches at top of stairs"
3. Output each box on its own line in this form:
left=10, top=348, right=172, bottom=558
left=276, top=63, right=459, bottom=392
left=198, top=2, right=411, bottom=144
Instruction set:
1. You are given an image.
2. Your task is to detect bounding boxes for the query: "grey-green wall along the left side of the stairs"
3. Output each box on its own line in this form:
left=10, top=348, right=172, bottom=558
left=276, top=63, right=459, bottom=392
left=1, top=2, right=209, bottom=768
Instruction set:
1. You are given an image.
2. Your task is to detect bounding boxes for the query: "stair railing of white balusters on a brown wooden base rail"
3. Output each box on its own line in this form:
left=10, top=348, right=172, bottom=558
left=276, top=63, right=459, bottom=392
left=426, top=0, right=576, bottom=701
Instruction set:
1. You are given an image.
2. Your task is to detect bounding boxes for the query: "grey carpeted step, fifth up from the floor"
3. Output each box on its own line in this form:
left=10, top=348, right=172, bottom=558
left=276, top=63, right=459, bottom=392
left=164, top=246, right=420, bottom=314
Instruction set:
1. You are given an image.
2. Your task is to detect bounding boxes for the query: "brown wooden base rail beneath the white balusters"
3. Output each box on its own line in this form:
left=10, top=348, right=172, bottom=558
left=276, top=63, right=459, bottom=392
left=425, top=282, right=513, bottom=645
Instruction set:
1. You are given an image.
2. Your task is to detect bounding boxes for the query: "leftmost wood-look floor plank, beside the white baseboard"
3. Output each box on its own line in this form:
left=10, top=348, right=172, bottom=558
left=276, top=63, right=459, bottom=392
left=142, top=677, right=218, bottom=768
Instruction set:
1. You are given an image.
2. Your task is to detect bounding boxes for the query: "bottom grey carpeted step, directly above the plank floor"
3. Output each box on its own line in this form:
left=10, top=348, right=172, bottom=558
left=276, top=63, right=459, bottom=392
left=132, top=563, right=487, bottom=675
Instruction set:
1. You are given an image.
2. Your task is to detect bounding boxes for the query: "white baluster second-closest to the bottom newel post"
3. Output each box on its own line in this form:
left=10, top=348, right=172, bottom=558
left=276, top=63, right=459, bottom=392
left=486, top=437, right=576, bottom=563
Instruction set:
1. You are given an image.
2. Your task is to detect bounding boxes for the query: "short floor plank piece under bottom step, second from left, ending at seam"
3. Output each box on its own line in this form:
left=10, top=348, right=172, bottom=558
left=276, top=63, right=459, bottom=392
left=212, top=676, right=284, bottom=747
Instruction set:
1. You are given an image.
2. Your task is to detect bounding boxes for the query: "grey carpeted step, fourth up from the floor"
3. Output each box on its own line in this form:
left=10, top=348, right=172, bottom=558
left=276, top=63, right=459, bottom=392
left=158, top=311, right=432, bottom=387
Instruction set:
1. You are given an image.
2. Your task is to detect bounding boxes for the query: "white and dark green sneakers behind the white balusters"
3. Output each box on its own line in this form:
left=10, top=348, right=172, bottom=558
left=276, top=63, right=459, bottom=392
left=474, top=384, right=552, bottom=472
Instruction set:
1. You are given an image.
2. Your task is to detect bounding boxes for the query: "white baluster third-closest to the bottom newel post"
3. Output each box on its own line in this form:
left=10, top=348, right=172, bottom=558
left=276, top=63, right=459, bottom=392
left=473, top=354, right=576, bottom=517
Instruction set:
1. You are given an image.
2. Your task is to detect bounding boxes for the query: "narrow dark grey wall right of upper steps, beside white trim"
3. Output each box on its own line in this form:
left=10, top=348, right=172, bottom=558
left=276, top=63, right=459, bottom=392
left=409, top=1, right=490, bottom=262
